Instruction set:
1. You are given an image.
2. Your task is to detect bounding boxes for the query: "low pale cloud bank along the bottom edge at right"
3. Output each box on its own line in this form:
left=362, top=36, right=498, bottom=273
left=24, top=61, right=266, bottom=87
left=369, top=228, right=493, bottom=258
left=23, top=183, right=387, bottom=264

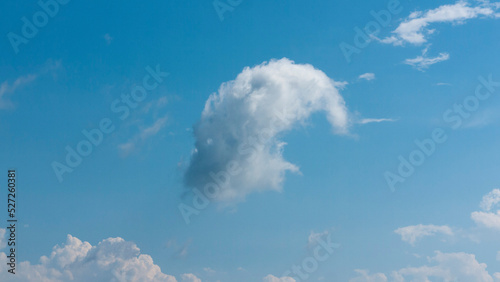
left=350, top=252, right=497, bottom=282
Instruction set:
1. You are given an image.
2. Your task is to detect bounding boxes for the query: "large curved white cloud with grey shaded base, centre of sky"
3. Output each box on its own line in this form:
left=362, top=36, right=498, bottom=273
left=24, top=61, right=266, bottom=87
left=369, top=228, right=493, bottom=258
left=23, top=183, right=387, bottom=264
left=184, top=58, right=350, bottom=202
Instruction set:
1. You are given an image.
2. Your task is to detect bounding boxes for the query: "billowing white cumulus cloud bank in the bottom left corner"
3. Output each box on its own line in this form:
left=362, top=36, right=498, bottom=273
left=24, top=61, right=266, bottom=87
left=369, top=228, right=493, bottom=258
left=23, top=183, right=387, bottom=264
left=0, top=235, right=182, bottom=282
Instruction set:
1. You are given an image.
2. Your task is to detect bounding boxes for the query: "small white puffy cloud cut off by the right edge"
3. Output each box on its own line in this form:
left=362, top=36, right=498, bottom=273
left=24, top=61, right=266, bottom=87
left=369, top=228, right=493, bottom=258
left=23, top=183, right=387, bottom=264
left=471, top=189, right=500, bottom=230
